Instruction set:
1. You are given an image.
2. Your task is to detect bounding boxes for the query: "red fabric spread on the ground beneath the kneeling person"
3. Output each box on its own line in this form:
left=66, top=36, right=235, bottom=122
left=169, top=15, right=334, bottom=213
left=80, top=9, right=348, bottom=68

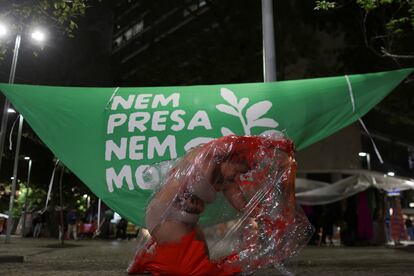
left=128, top=230, right=241, bottom=276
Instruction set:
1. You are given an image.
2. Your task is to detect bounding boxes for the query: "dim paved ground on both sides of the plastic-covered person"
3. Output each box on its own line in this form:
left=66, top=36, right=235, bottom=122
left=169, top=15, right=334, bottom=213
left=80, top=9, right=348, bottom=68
left=0, top=237, right=414, bottom=276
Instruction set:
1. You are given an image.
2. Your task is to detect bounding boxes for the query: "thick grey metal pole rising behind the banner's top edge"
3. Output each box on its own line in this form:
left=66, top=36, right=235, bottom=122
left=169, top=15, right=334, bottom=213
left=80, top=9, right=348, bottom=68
left=262, top=0, right=276, bottom=82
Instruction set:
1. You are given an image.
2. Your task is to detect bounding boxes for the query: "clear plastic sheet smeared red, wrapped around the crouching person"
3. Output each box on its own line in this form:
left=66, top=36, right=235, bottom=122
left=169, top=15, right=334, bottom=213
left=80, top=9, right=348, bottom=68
left=128, top=135, right=313, bottom=275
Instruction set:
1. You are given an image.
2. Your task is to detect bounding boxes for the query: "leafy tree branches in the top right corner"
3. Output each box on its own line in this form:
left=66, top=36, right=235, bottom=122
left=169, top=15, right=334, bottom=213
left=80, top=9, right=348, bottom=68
left=315, top=0, right=414, bottom=63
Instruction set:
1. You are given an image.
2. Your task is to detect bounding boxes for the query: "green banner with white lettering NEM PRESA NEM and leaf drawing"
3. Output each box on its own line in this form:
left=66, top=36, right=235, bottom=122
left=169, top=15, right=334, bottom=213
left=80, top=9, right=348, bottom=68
left=0, top=69, right=413, bottom=225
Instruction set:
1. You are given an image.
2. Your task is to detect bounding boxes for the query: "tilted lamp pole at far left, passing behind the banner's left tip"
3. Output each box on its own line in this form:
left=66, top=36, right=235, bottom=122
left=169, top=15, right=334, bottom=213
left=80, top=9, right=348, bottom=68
left=0, top=34, right=21, bottom=175
